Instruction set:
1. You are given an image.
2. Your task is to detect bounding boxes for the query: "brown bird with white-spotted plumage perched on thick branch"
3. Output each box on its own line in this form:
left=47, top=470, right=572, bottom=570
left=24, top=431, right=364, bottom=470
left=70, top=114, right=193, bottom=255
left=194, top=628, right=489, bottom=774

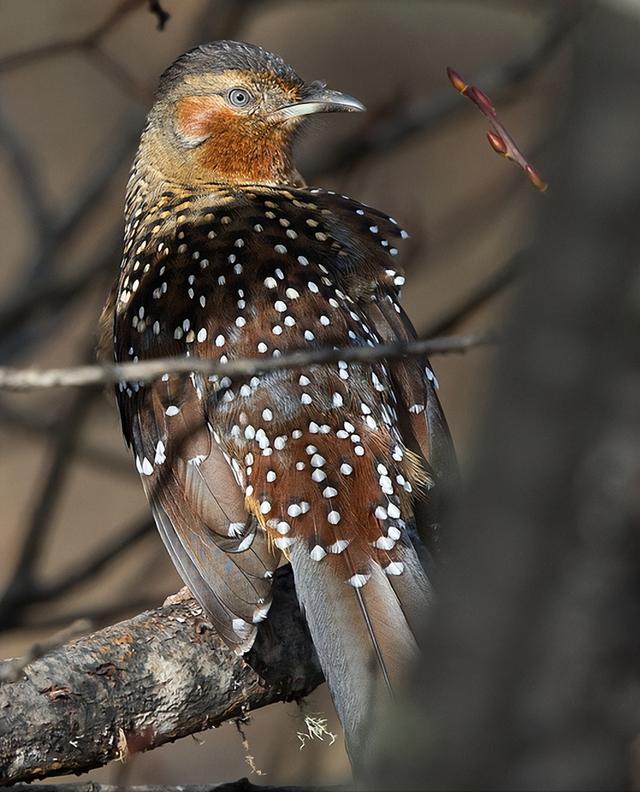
left=99, top=41, right=455, bottom=763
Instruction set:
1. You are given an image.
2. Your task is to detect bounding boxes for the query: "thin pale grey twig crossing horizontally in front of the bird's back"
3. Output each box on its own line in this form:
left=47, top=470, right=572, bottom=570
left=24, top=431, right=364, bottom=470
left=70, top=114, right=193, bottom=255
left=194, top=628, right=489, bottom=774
left=0, top=332, right=496, bottom=390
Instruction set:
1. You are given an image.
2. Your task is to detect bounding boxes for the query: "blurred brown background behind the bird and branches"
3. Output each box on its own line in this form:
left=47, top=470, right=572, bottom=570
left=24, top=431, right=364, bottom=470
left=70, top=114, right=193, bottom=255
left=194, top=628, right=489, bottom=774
left=0, top=0, right=570, bottom=784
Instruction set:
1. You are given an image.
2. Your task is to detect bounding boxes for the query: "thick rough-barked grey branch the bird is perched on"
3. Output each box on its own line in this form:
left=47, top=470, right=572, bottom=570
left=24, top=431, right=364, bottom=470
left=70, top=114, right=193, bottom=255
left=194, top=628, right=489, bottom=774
left=0, top=567, right=323, bottom=784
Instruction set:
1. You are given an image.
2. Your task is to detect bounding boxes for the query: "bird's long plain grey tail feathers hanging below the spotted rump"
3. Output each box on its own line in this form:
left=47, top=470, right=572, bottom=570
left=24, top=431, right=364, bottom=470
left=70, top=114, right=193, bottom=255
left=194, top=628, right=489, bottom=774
left=290, top=543, right=431, bottom=768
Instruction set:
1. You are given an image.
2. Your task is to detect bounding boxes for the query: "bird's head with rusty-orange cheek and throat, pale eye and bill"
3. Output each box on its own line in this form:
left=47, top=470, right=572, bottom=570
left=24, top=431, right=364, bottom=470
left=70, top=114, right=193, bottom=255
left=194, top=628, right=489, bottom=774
left=143, top=41, right=365, bottom=184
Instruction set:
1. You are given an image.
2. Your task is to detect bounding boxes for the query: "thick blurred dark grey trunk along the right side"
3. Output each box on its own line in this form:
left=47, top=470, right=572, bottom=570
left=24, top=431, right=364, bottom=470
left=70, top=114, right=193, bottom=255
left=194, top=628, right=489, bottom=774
left=374, top=3, right=640, bottom=790
